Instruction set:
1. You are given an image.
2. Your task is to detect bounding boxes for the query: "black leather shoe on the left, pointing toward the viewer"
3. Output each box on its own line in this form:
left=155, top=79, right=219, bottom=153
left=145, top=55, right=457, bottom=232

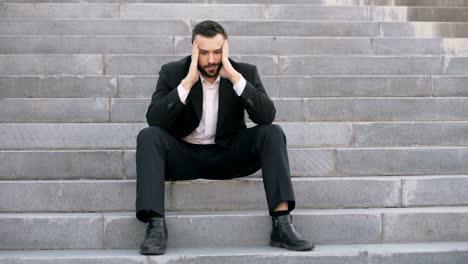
left=140, top=217, right=168, bottom=255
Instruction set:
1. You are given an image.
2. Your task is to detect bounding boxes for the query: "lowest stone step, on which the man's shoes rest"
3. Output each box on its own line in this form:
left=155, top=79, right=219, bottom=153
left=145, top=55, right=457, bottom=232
left=0, top=242, right=468, bottom=264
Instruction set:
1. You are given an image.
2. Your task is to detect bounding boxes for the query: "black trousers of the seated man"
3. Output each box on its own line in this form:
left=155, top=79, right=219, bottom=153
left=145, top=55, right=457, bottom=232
left=136, top=124, right=296, bottom=222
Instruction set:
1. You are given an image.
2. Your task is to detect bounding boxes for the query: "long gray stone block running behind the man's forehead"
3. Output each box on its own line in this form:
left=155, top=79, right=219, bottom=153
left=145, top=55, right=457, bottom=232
left=175, top=36, right=372, bottom=55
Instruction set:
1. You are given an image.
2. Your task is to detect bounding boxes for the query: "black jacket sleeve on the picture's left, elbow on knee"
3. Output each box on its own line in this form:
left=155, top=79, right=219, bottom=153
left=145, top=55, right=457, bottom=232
left=146, top=65, right=185, bottom=130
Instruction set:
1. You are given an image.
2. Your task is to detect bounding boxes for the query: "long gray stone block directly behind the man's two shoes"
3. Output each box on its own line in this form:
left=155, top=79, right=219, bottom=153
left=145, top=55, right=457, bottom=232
left=104, top=210, right=381, bottom=248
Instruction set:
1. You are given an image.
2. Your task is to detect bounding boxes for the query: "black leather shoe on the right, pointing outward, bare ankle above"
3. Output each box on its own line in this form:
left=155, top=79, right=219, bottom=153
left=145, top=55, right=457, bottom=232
left=270, top=214, right=314, bottom=251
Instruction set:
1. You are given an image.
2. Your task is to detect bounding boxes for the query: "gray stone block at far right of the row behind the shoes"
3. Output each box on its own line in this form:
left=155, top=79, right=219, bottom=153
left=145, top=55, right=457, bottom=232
left=383, top=207, right=468, bottom=243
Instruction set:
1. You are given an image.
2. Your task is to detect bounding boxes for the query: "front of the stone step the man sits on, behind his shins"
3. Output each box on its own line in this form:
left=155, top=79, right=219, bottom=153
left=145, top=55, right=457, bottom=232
left=0, top=175, right=468, bottom=213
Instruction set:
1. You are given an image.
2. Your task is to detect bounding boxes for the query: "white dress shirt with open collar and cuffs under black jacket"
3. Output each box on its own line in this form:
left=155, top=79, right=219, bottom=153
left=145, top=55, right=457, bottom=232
left=177, top=75, right=247, bottom=144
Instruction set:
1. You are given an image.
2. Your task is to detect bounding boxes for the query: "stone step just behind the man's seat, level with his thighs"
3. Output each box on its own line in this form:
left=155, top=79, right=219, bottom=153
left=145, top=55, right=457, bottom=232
left=0, top=142, right=468, bottom=177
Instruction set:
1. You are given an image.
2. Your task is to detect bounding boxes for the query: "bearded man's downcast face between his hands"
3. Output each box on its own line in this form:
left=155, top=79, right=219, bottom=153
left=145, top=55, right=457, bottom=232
left=195, top=34, right=224, bottom=78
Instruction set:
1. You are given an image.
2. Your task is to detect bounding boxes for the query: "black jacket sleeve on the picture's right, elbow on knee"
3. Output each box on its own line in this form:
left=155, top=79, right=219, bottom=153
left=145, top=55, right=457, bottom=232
left=241, top=66, right=276, bottom=125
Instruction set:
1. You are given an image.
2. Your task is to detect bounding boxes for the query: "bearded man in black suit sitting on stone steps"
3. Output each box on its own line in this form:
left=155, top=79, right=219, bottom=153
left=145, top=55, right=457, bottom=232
left=136, top=20, right=314, bottom=255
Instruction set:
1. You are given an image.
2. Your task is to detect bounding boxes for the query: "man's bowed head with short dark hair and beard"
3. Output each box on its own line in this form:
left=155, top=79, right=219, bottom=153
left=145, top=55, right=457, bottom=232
left=192, top=20, right=227, bottom=78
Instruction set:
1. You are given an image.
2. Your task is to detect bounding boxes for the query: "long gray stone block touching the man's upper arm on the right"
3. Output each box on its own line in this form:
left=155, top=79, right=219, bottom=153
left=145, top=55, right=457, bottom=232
left=278, top=75, right=431, bottom=97
